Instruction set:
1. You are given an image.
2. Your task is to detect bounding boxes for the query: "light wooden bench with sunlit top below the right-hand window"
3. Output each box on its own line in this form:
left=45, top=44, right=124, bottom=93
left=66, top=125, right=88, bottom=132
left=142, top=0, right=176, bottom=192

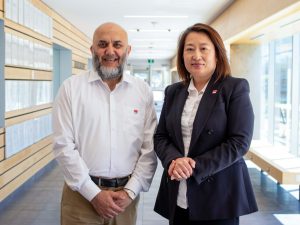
left=246, top=141, right=300, bottom=201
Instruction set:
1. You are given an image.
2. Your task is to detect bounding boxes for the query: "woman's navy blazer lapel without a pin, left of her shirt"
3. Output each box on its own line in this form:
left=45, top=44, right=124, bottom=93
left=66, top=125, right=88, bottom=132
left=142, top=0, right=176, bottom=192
left=174, top=86, right=188, bottom=154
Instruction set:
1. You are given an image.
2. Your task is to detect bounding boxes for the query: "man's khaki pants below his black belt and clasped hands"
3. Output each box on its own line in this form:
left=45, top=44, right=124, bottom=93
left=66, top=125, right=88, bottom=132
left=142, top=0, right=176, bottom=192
left=61, top=184, right=139, bottom=225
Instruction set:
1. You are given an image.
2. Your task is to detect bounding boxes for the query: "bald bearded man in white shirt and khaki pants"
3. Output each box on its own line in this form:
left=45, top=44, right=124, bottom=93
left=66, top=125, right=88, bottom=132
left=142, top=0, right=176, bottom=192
left=53, top=23, right=157, bottom=225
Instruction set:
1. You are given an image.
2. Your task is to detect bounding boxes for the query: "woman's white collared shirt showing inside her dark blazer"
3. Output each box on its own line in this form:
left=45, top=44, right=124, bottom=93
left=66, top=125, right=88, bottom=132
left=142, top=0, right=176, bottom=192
left=177, top=79, right=208, bottom=209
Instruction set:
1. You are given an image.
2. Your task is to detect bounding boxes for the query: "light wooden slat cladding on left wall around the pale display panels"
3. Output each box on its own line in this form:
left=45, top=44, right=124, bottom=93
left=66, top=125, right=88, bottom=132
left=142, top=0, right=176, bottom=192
left=0, top=0, right=91, bottom=201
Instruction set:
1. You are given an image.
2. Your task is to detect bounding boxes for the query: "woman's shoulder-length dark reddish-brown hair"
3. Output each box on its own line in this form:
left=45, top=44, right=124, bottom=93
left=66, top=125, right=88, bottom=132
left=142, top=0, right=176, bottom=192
left=177, top=23, right=231, bottom=84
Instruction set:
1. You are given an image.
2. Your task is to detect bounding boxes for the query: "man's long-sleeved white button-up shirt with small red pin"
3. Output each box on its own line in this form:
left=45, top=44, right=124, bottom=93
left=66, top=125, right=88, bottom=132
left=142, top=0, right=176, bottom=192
left=53, top=71, right=157, bottom=201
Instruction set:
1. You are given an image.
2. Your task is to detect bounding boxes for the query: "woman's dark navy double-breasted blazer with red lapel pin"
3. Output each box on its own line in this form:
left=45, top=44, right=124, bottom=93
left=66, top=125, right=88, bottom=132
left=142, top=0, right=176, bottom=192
left=154, top=75, right=257, bottom=224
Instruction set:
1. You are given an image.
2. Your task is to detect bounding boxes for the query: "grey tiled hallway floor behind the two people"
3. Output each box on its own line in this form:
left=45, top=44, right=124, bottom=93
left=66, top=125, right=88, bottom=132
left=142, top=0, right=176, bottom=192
left=0, top=160, right=300, bottom=225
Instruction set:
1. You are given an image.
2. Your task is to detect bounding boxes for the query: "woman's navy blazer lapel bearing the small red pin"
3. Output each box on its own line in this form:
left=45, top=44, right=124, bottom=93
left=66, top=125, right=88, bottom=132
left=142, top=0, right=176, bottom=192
left=189, top=77, right=221, bottom=150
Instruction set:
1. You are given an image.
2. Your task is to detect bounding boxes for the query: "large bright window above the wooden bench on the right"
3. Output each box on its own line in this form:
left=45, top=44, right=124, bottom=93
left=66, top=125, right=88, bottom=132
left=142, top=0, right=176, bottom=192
left=260, top=34, right=300, bottom=157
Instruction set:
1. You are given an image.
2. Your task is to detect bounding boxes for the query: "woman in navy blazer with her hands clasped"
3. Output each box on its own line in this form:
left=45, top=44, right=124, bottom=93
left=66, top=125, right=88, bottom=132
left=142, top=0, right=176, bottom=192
left=154, top=23, right=257, bottom=225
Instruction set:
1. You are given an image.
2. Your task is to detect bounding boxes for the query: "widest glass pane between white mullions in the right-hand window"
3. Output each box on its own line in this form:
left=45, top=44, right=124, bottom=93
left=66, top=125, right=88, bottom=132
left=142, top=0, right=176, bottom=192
left=274, top=37, right=292, bottom=149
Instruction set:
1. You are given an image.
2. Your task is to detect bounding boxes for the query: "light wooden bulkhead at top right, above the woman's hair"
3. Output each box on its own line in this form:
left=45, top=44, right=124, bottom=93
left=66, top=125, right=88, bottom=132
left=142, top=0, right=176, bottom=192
left=210, top=0, right=300, bottom=44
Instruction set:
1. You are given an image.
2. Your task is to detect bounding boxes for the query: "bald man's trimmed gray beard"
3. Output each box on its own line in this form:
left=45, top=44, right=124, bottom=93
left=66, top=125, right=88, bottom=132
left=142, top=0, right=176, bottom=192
left=93, top=53, right=127, bottom=81
